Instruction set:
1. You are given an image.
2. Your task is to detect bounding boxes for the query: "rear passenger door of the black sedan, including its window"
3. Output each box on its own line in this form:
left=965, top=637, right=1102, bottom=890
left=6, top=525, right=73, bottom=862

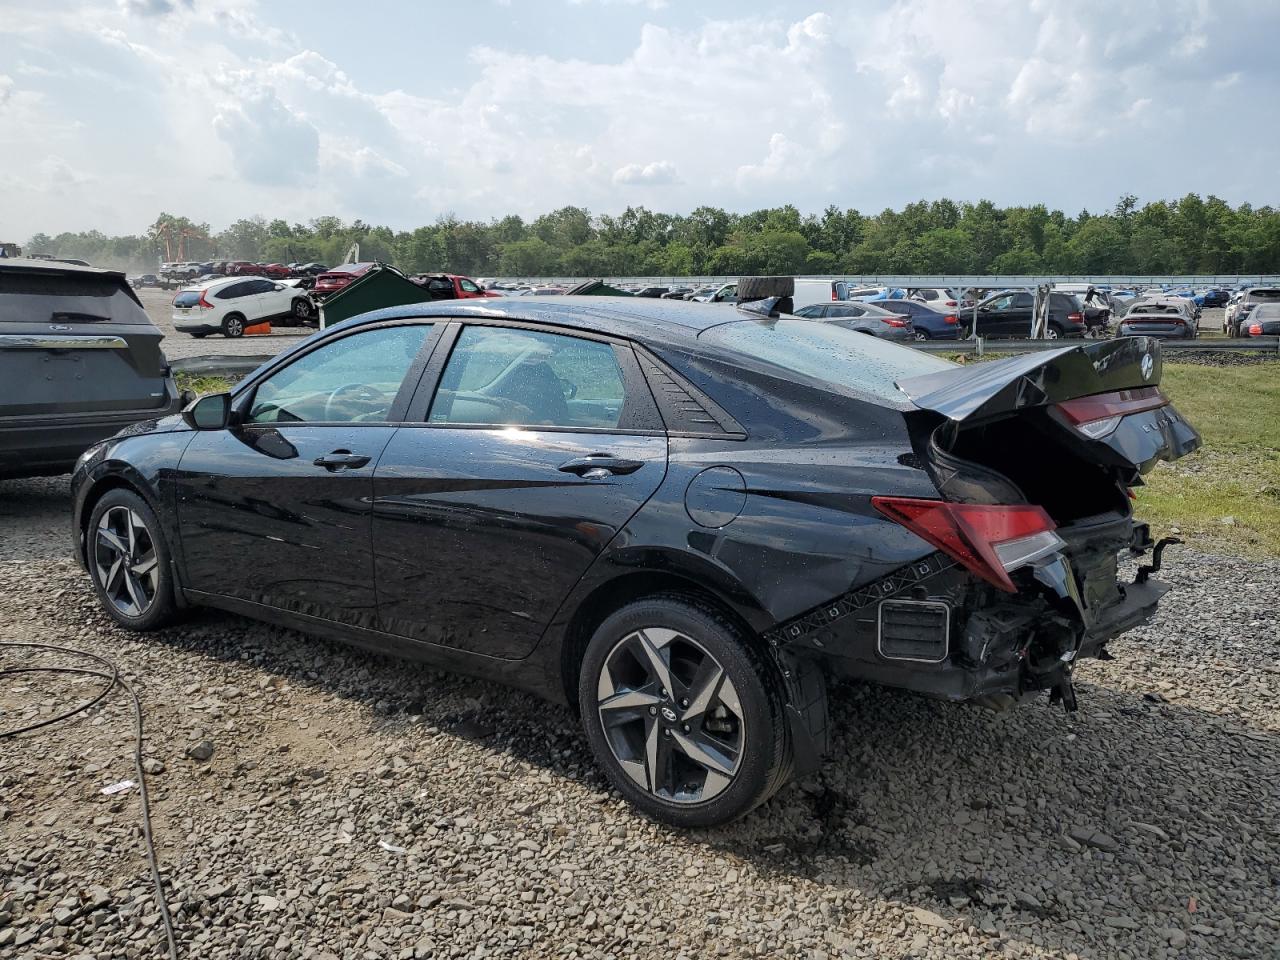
left=374, top=325, right=667, bottom=658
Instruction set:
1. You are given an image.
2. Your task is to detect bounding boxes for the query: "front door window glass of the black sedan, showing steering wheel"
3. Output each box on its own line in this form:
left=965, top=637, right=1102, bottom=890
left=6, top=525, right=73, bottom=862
left=246, top=324, right=431, bottom=424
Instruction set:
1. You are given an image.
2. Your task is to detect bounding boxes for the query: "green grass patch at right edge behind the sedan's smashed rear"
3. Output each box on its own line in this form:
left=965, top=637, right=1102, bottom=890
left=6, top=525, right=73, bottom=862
left=1137, top=362, right=1280, bottom=556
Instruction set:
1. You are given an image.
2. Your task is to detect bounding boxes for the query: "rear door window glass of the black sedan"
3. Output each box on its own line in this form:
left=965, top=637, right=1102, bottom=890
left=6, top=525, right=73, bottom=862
left=428, top=326, right=626, bottom=429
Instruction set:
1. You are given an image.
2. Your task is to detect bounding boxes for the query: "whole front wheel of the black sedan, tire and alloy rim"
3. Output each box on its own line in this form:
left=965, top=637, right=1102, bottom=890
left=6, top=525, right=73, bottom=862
left=84, top=489, right=177, bottom=632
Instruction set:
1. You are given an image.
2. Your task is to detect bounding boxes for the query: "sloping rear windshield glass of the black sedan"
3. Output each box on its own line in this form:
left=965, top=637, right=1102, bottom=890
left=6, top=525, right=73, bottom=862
left=699, top=317, right=954, bottom=402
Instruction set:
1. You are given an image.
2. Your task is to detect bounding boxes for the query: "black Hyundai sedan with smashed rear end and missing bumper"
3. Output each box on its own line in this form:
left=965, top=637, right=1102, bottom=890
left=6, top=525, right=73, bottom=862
left=73, top=297, right=1199, bottom=826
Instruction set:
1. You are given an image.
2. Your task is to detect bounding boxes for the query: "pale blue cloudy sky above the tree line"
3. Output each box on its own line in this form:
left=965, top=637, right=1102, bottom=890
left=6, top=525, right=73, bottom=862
left=0, top=0, right=1280, bottom=242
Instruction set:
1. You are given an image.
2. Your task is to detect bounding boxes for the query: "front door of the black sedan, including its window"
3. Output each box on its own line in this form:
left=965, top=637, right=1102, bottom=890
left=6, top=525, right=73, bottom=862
left=177, top=323, right=433, bottom=627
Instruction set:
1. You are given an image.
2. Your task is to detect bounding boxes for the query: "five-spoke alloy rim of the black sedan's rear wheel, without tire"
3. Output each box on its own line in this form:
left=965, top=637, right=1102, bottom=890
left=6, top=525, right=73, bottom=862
left=596, top=627, right=746, bottom=804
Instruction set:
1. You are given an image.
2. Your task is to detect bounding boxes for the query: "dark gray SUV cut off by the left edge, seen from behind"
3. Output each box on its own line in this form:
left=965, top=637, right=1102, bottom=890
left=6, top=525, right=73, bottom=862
left=0, top=259, right=179, bottom=477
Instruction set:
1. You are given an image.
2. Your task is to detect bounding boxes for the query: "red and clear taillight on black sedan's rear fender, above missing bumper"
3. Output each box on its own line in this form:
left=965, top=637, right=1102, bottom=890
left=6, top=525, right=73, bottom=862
left=872, top=497, right=1062, bottom=593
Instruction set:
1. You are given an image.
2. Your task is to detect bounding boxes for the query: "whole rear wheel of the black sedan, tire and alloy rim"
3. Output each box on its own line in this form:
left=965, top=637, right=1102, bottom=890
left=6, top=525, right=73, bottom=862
left=579, top=595, right=792, bottom=827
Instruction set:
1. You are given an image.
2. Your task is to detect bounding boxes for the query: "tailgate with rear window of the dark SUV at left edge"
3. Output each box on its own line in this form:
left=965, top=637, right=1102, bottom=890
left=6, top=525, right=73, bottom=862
left=0, top=261, right=166, bottom=425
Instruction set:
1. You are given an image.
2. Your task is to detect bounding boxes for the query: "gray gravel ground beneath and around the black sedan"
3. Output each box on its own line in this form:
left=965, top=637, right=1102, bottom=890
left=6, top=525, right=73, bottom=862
left=0, top=481, right=1280, bottom=960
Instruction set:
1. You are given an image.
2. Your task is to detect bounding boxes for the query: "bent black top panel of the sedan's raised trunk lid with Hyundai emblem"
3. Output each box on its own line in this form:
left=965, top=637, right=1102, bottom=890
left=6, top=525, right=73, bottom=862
left=895, top=337, right=1162, bottom=422
